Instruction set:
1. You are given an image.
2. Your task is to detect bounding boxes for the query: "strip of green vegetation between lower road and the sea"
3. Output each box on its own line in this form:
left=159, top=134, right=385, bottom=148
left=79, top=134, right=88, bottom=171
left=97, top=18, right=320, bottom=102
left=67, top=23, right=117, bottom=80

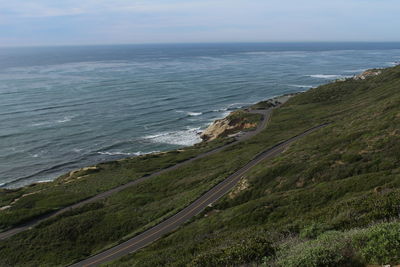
left=0, top=139, right=232, bottom=230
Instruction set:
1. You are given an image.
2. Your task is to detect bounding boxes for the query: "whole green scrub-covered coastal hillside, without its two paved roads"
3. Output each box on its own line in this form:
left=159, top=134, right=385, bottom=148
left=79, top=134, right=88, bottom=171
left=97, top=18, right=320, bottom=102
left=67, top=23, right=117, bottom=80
left=0, top=67, right=400, bottom=266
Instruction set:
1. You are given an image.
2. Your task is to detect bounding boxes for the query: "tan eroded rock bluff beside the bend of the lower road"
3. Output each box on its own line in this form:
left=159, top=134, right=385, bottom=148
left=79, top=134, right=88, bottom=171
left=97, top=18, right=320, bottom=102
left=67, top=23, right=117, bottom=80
left=200, top=111, right=257, bottom=141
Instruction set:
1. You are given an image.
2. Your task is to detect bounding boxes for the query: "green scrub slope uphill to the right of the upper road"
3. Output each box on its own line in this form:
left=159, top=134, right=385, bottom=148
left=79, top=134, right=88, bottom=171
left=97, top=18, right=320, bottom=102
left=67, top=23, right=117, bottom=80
left=105, top=67, right=400, bottom=266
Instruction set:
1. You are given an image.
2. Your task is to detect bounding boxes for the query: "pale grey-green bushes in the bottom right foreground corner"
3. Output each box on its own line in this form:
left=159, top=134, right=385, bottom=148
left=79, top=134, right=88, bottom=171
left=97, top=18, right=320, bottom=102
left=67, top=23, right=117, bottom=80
left=270, top=221, right=400, bottom=267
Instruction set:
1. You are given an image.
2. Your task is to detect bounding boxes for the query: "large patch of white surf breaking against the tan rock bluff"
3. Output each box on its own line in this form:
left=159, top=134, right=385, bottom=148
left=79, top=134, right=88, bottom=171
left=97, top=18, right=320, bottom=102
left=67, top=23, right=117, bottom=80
left=144, top=127, right=201, bottom=146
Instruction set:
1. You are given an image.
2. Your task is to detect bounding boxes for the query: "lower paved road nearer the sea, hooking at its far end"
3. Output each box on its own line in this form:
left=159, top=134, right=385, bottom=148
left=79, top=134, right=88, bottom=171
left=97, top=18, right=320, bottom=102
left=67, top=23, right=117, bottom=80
left=0, top=109, right=272, bottom=240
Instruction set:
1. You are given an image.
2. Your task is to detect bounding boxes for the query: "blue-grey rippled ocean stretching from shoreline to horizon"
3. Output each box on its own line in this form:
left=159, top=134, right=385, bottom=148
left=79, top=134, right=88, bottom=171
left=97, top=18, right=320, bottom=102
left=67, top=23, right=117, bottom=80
left=0, top=43, right=400, bottom=188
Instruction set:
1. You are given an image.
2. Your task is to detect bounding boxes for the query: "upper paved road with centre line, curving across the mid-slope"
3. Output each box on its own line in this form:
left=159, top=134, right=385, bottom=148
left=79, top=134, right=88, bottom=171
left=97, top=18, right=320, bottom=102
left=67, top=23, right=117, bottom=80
left=72, top=123, right=328, bottom=267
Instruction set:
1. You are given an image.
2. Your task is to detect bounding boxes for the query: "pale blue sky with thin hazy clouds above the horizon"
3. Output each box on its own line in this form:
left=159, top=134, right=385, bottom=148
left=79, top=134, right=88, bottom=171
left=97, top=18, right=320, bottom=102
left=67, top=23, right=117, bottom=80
left=0, top=0, right=400, bottom=46
